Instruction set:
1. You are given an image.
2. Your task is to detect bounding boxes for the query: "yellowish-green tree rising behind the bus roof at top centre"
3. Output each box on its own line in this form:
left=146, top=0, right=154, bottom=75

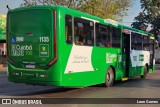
left=21, top=0, right=132, bottom=21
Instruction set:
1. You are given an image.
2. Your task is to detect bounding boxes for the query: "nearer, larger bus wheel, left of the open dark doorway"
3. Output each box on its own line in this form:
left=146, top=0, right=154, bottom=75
left=105, top=67, right=114, bottom=87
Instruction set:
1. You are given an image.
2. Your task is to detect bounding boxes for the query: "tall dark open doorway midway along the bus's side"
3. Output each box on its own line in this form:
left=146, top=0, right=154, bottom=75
left=122, top=30, right=131, bottom=78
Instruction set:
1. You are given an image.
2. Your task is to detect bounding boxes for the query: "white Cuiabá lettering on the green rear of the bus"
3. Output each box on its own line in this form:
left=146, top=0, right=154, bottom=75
left=11, top=45, right=32, bottom=56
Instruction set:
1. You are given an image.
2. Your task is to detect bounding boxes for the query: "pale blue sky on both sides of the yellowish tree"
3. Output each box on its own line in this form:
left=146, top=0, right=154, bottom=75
left=0, top=0, right=141, bottom=26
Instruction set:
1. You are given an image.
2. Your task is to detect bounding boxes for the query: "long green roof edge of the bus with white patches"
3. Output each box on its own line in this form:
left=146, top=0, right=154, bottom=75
left=8, top=5, right=152, bottom=35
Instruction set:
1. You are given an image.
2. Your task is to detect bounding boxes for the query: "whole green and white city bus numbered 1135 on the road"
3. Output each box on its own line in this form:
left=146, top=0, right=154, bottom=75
left=7, top=6, right=155, bottom=87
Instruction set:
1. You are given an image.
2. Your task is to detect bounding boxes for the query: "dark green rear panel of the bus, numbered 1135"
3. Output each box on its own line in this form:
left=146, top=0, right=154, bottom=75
left=8, top=9, right=54, bottom=69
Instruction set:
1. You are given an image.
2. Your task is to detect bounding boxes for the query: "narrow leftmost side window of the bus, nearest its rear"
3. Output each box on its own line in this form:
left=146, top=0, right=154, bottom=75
left=65, top=15, right=72, bottom=44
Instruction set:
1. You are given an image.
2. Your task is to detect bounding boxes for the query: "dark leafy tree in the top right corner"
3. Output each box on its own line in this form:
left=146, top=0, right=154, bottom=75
left=132, top=0, right=160, bottom=35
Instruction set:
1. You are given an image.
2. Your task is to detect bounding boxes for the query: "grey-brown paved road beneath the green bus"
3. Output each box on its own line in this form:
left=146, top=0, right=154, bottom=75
left=0, top=65, right=160, bottom=107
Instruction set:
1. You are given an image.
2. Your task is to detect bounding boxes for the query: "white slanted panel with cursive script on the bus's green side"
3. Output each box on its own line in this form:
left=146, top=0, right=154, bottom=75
left=64, top=45, right=94, bottom=74
